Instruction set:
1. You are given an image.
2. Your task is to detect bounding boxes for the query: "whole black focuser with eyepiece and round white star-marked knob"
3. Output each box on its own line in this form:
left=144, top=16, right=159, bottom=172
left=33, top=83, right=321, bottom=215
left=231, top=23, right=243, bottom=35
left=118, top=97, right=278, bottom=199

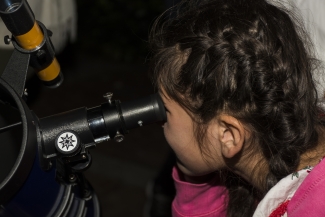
left=38, top=93, right=166, bottom=178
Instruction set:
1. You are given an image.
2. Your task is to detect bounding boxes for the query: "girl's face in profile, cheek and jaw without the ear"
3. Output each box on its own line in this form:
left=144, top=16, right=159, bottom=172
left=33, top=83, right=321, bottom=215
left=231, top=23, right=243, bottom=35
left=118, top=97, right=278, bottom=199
left=160, top=91, right=222, bottom=176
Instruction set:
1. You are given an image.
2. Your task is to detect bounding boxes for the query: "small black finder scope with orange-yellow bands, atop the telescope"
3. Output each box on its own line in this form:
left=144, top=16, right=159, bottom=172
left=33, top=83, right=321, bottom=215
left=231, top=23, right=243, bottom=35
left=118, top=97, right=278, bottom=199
left=0, top=0, right=63, bottom=87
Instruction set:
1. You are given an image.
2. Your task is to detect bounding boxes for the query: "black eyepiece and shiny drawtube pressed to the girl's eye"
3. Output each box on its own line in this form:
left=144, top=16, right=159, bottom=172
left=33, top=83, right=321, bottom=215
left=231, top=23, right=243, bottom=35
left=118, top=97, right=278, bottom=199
left=87, top=94, right=167, bottom=141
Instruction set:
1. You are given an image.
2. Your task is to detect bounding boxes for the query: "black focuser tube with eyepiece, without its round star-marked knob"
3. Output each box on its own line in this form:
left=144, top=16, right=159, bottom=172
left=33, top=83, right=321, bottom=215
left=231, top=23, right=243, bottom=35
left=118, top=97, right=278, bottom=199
left=38, top=94, right=167, bottom=159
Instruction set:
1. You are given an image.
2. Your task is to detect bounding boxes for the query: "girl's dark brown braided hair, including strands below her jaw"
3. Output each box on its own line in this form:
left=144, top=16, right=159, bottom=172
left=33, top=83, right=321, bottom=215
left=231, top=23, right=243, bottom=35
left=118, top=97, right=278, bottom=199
left=150, top=0, right=319, bottom=216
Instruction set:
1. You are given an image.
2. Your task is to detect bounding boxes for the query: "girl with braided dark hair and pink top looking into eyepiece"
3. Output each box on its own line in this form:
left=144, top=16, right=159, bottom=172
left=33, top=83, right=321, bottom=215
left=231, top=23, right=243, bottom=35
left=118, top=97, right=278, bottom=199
left=151, top=0, right=325, bottom=217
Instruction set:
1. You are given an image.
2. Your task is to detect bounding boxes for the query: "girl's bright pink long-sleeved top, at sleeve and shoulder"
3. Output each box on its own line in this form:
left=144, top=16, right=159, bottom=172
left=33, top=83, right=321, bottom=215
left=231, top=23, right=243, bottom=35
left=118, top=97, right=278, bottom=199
left=172, top=160, right=325, bottom=217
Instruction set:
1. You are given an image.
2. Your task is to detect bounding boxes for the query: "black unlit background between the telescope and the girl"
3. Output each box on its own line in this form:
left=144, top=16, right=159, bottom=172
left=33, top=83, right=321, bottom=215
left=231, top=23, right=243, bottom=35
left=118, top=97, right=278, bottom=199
left=20, top=0, right=173, bottom=217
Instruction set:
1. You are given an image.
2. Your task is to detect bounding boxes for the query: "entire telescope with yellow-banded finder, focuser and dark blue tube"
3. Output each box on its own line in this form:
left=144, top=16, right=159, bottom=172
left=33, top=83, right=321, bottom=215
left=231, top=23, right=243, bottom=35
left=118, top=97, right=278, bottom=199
left=0, top=0, right=166, bottom=217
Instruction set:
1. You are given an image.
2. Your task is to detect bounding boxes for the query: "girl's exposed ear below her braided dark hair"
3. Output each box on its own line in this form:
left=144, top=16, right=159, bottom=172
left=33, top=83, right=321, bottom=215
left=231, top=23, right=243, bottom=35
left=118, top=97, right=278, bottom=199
left=218, top=115, right=246, bottom=158
